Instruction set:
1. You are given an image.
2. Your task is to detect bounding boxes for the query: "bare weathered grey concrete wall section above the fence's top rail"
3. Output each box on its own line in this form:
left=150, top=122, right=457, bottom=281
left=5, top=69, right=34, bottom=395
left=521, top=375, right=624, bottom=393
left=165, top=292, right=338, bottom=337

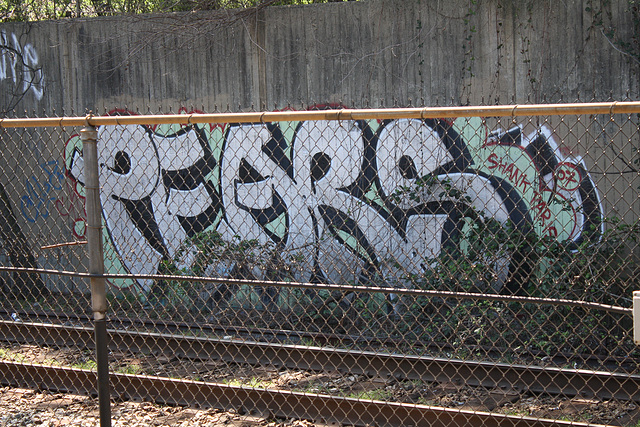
left=0, top=0, right=638, bottom=114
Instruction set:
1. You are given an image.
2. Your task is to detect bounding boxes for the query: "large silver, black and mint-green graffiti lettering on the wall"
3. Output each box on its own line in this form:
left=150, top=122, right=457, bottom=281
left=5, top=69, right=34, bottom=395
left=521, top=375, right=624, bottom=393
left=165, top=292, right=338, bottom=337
left=66, top=112, right=602, bottom=300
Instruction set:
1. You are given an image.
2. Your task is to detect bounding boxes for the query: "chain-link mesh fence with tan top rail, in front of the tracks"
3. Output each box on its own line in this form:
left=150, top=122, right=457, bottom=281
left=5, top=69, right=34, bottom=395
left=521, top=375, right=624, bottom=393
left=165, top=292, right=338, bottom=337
left=0, top=103, right=640, bottom=425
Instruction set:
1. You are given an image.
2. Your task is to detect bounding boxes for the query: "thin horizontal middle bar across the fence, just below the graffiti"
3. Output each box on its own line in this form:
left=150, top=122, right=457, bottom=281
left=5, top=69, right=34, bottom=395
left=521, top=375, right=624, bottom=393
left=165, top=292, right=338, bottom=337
left=0, top=266, right=633, bottom=316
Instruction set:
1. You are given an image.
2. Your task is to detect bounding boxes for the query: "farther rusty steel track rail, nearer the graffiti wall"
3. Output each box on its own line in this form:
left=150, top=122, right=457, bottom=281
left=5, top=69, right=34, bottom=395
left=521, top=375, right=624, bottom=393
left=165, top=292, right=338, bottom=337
left=0, top=321, right=640, bottom=402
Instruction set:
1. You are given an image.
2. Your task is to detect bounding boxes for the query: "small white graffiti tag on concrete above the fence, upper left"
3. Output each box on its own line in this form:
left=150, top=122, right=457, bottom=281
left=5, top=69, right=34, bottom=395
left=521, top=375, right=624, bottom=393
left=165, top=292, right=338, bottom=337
left=0, top=30, right=44, bottom=101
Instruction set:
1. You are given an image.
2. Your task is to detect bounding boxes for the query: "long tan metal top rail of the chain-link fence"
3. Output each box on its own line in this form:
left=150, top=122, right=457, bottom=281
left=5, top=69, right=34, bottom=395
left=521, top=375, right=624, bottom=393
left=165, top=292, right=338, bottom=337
left=0, top=101, right=640, bottom=128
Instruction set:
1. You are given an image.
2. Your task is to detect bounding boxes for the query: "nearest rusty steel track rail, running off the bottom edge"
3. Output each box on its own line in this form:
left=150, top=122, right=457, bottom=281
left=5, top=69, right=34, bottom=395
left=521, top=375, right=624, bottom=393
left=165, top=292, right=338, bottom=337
left=0, top=361, right=595, bottom=427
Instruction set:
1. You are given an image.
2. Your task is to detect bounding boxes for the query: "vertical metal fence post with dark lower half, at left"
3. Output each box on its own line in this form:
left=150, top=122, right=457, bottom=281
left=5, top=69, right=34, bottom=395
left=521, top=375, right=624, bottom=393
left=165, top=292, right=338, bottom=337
left=80, top=125, right=111, bottom=427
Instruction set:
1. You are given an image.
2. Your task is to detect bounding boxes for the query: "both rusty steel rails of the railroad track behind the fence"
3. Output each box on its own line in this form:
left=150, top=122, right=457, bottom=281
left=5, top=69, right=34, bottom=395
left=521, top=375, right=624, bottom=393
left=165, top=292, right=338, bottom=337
left=0, top=318, right=640, bottom=426
